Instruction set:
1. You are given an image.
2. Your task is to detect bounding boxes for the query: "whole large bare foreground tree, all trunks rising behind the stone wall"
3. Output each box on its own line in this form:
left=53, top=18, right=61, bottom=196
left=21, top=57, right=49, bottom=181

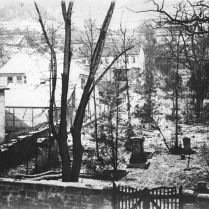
left=35, top=1, right=130, bottom=182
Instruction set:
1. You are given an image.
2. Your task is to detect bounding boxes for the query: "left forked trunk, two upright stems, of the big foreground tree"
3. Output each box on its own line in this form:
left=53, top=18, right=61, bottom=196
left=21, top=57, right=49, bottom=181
left=35, top=1, right=73, bottom=182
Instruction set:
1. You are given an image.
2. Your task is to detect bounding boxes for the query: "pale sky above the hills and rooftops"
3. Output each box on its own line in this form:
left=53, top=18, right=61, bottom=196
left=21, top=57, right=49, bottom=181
left=0, top=0, right=185, bottom=29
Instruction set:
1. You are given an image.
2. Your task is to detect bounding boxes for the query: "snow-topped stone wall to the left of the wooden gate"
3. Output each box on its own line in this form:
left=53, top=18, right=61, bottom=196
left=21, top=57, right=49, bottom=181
left=0, top=179, right=112, bottom=209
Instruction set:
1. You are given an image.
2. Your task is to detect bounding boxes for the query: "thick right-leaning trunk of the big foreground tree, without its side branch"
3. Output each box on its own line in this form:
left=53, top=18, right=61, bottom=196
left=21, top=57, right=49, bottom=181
left=71, top=2, right=115, bottom=182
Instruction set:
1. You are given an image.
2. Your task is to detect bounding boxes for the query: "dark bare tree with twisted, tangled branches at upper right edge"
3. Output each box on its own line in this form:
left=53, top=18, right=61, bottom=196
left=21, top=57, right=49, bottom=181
left=129, top=0, right=209, bottom=118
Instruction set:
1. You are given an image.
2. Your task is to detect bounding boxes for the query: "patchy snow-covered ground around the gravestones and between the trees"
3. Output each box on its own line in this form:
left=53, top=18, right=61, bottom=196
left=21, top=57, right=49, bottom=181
left=3, top=84, right=209, bottom=192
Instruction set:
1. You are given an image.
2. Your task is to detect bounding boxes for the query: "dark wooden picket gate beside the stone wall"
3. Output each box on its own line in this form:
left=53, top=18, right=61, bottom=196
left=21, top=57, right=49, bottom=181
left=114, top=186, right=183, bottom=209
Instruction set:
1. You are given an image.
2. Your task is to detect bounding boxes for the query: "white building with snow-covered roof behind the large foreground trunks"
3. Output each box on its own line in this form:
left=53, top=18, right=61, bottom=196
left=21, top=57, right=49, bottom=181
left=0, top=53, right=99, bottom=131
